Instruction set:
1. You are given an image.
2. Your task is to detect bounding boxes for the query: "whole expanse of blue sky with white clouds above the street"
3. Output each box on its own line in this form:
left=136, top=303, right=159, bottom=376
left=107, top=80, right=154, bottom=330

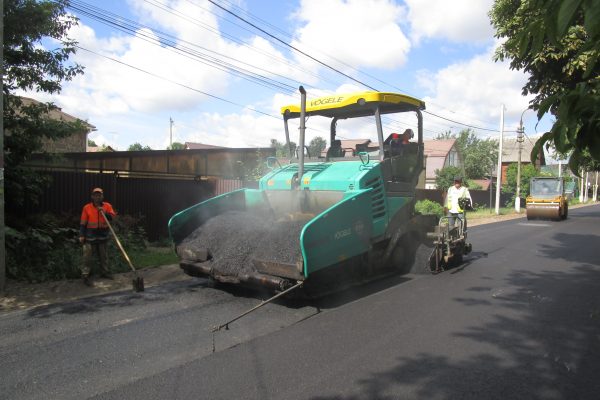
left=30, top=0, right=549, bottom=150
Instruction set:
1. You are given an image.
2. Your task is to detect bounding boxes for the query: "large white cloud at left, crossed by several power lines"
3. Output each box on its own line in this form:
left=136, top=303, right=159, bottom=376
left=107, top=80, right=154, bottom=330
left=59, top=1, right=314, bottom=118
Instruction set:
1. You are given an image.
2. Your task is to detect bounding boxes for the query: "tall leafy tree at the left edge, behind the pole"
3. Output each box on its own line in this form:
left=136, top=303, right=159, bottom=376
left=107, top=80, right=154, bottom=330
left=2, top=0, right=85, bottom=212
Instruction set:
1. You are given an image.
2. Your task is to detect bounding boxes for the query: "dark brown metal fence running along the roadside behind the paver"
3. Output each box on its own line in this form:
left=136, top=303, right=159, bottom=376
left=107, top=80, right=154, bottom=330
left=19, top=171, right=510, bottom=241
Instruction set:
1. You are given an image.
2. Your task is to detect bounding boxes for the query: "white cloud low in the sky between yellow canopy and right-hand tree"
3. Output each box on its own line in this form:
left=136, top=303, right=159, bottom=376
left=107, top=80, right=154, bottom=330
left=419, top=48, right=530, bottom=133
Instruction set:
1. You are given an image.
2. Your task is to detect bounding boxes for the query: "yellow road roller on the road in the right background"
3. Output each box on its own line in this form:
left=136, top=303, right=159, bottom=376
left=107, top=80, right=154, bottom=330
left=526, top=177, right=569, bottom=221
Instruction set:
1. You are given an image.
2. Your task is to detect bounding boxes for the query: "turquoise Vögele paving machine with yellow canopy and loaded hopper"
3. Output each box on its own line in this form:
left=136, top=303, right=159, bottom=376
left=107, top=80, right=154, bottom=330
left=169, top=87, right=444, bottom=294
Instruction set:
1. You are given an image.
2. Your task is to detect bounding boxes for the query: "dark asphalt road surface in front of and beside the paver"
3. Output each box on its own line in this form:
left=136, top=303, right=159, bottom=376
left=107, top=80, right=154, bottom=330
left=0, top=205, right=600, bottom=400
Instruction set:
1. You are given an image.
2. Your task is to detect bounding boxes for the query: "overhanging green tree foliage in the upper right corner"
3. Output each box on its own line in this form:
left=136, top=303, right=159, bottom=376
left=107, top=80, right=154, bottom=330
left=490, top=0, right=600, bottom=174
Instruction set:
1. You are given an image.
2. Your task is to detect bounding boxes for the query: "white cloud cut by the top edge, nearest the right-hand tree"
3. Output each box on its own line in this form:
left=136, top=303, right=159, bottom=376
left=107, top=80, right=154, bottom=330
left=405, top=0, right=494, bottom=43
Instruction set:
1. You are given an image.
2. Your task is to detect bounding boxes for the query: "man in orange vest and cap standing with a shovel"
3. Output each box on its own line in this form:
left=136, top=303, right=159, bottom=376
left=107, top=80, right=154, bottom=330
left=79, top=188, right=116, bottom=286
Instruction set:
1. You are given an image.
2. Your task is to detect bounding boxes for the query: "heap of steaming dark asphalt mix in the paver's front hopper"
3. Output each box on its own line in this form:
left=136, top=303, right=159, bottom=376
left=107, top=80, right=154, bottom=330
left=179, top=211, right=305, bottom=276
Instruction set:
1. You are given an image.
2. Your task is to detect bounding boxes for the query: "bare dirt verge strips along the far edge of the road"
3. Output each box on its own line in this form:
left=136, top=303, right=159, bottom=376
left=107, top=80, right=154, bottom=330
left=0, top=206, right=580, bottom=313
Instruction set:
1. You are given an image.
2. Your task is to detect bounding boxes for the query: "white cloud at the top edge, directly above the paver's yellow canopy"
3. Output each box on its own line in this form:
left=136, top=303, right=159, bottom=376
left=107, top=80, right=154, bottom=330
left=292, top=0, right=410, bottom=70
